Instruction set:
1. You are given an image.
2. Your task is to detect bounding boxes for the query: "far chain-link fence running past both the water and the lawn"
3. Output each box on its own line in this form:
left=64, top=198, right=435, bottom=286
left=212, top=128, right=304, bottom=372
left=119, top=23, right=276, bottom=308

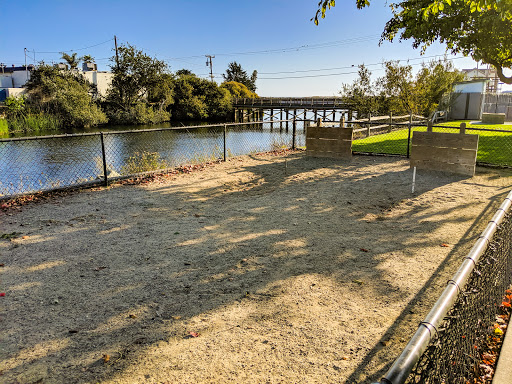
left=0, top=116, right=512, bottom=198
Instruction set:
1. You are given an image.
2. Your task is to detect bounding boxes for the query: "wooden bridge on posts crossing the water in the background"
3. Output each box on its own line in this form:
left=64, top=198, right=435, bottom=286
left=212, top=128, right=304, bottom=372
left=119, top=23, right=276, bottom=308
left=233, top=96, right=353, bottom=122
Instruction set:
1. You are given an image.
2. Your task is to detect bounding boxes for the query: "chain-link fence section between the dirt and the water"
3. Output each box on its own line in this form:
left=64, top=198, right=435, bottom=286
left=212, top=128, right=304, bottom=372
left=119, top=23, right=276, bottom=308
left=0, top=121, right=304, bottom=198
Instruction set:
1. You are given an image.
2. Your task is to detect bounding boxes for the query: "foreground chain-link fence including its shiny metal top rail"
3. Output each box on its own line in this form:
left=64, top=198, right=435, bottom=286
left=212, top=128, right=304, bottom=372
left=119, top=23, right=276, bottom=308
left=381, top=192, right=512, bottom=384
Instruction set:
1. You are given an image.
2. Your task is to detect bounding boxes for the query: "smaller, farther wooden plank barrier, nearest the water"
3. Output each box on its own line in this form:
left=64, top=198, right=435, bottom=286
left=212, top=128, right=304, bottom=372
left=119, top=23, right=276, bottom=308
left=306, top=119, right=353, bottom=159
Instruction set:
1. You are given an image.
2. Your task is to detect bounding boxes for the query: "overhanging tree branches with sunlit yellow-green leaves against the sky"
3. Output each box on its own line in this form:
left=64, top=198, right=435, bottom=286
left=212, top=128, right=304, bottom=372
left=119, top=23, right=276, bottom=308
left=314, top=0, right=512, bottom=84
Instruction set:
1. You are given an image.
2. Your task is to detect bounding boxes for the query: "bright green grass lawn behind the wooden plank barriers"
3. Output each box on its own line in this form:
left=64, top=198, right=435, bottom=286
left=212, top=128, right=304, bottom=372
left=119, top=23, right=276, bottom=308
left=352, top=120, right=512, bottom=166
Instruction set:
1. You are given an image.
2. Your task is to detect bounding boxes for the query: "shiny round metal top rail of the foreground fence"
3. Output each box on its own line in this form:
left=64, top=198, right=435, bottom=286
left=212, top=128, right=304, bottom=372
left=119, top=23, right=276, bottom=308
left=380, top=191, right=512, bottom=384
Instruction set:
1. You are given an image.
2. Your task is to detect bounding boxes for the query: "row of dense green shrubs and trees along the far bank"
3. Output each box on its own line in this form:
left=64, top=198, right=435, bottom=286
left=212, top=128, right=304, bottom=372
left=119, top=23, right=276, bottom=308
left=6, top=44, right=257, bottom=132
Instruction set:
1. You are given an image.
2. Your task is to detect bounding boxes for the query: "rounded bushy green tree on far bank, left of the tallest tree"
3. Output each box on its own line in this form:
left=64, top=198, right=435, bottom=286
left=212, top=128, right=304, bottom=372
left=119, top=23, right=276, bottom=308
left=26, top=65, right=107, bottom=127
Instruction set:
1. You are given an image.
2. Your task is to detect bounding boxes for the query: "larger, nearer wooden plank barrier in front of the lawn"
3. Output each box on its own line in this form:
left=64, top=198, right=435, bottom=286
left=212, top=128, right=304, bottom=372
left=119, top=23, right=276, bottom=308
left=411, top=123, right=478, bottom=176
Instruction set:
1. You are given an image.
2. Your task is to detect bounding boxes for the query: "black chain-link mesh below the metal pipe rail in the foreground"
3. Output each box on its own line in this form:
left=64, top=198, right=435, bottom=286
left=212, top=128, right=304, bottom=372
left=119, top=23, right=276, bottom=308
left=407, top=212, right=512, bottom=384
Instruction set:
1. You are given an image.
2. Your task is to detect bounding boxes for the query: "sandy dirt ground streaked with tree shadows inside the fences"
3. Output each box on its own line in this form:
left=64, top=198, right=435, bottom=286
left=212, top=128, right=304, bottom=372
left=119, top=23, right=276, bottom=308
left=0, top=152, right=512, bottom=383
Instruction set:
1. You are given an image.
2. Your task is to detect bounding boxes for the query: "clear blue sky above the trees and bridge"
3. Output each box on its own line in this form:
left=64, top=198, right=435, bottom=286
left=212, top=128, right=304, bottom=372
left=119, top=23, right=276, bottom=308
left=0, top=0, right=492, bottom=96
